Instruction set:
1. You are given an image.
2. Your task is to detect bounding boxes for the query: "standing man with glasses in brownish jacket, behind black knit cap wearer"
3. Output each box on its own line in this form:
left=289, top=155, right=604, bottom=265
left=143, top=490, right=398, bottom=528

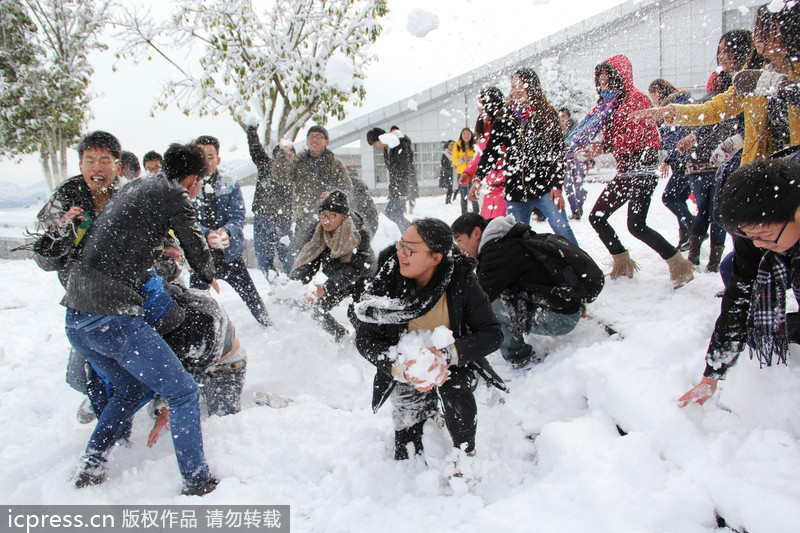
left=272, top=126, right=353, bottom=235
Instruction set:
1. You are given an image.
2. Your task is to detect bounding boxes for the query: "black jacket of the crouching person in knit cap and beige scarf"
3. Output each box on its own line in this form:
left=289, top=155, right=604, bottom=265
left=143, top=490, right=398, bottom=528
left=291, top=213, right=375, bottom=301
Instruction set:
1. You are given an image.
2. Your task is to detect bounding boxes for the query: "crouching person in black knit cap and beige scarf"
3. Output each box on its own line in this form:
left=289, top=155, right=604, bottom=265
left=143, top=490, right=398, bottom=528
left=290, top=190, right=375, bottom=342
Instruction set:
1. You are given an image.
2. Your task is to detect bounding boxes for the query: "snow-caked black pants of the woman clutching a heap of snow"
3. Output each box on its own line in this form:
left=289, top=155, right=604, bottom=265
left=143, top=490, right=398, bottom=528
left=392, top=367, right=478, bottom=457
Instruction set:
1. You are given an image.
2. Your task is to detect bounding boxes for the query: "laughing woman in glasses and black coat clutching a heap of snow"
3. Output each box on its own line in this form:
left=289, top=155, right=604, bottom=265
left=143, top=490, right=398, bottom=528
left=351, top=218, right=505, bottom=460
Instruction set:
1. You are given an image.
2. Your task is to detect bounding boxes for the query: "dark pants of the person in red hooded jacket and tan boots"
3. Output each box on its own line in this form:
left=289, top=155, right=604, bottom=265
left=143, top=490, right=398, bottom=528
left=589, top=167, right=678, bottom=259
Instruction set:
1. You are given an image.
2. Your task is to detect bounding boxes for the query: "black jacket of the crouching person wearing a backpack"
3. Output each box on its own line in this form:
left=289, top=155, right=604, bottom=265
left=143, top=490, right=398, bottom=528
left=478, top=222, right=581, bottom=314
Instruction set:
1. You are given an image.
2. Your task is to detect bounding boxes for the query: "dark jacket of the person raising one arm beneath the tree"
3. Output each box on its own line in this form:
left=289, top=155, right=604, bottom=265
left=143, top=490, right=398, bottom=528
left=247, top=127, right=292, bottom=223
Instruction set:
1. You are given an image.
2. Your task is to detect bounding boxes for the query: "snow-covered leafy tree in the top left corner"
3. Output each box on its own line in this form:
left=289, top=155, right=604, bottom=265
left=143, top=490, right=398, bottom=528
left=0, top=0, right=110, bottom=190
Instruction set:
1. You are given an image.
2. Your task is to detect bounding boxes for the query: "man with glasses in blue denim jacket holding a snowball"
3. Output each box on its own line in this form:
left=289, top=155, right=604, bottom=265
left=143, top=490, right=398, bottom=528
left=190, top=135, right=272, bottom=327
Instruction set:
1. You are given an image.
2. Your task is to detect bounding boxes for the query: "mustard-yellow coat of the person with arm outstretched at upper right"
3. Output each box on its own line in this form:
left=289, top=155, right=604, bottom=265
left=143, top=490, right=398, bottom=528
left=668, top=69, right=800, bottom=165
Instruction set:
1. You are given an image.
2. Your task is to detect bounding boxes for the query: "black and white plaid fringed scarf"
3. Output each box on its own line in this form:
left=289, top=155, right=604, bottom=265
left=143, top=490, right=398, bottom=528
left=747, top=245, right=800, bottom=367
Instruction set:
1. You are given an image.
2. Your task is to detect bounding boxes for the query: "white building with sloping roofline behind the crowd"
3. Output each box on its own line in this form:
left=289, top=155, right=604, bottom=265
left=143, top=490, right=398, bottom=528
left=330, top=0, right=765, bottom=191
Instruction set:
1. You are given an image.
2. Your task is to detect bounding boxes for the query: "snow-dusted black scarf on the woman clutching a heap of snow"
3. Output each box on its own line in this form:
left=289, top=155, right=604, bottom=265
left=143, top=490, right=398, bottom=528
left=355, top=247, right=455, bottom=324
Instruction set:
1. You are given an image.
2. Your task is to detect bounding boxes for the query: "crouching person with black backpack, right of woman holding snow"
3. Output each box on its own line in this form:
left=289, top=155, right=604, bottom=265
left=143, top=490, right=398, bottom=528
left=452, top=213, right=603, bottom=367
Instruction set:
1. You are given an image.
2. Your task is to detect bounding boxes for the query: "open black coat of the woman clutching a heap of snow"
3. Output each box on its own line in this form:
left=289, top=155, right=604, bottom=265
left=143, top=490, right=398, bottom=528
left=350, top=246, right=506, bottom=411
